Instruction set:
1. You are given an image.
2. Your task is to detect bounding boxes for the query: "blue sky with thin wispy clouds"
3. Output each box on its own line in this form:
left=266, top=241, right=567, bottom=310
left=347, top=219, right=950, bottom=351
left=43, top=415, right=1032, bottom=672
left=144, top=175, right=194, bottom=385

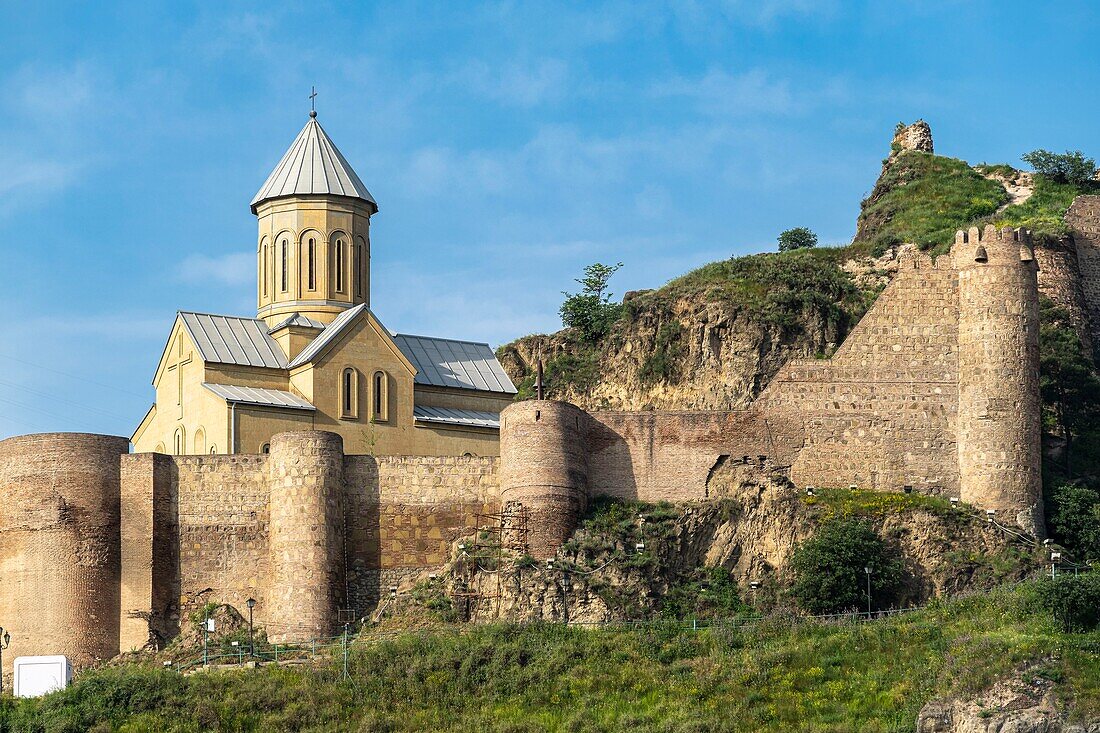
left=0, top=0, right=1100, bottom=438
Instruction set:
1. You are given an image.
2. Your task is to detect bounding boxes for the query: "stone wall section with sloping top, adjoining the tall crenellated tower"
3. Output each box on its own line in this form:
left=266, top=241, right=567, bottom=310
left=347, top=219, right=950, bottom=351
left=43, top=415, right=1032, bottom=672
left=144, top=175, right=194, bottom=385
left=760, top=248, right=958, bottom=494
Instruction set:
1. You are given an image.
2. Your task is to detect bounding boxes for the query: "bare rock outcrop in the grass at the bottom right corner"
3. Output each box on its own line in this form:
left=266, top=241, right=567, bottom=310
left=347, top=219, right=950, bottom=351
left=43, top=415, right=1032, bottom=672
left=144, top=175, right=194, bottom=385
left=916, top=671, right=1100, bottom=733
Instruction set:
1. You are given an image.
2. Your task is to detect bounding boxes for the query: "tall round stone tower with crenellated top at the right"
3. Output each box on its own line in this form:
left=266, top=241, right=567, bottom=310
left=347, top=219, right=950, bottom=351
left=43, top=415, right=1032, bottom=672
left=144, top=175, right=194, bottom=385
left=953, top=226, right=1043, bottom=536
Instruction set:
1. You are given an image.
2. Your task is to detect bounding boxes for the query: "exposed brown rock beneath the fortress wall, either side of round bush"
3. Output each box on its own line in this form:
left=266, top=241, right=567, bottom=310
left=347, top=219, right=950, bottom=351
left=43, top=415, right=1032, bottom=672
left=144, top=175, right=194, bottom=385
left=406, top=473, right=1027, bottom=622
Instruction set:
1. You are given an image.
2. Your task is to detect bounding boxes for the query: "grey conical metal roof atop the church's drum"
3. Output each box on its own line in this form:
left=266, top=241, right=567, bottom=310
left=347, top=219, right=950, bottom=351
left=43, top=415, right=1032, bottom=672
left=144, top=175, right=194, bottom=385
left=252, top=113, right=378, bottom=214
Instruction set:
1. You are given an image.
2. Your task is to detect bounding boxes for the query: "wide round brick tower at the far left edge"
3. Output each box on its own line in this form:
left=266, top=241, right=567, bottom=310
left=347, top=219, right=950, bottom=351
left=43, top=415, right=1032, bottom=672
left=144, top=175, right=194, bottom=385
left=0, top=433, right=130, bottom=677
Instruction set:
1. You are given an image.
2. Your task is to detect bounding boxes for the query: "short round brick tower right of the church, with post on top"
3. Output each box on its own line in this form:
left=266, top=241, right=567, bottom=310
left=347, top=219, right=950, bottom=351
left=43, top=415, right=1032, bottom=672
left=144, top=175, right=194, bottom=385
left=501, top=400, right=590, bottom=559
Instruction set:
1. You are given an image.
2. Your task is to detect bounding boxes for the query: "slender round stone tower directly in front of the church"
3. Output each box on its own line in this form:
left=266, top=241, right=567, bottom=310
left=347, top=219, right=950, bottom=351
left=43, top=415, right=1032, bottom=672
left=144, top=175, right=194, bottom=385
left=264, top=430, right=347, bottom=643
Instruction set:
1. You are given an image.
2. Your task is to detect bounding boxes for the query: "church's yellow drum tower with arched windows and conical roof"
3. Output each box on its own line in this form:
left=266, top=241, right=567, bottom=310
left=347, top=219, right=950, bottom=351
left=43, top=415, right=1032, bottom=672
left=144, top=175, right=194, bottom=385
left=252, top=112, right=378, bottom=326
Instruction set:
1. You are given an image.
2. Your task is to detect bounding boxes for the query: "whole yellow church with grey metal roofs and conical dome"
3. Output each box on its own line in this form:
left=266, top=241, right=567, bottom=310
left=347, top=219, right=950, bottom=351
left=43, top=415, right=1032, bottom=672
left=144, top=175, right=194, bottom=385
left=131, top=111, right=516, bottom=456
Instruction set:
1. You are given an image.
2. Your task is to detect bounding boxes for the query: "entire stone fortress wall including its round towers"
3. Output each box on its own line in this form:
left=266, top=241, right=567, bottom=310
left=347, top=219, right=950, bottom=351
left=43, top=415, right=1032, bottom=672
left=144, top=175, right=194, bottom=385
left=0, top=215, right=1082, bottom=670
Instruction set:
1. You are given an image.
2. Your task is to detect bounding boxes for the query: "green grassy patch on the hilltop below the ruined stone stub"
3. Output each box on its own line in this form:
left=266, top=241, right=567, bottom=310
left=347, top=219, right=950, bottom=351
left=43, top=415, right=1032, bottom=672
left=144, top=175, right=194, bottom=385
left=859, top=151, right=1009, bottom=254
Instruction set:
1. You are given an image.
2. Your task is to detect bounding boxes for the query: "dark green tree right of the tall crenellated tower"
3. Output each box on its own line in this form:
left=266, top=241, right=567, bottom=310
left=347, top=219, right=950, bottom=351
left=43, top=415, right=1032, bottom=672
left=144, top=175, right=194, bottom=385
left=1038, top=297, right=1100, bottom=469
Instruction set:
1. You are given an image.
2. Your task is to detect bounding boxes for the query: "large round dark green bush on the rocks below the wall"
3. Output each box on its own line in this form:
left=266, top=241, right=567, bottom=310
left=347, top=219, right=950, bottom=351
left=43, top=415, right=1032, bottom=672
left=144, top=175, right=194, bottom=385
left=791, top=517, right=904, bottom=614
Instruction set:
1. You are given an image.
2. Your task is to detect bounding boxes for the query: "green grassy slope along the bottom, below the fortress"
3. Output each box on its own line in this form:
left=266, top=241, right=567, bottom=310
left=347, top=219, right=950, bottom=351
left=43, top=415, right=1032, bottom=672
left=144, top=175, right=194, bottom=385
left=0, top=588, right=1100, bottom=733
